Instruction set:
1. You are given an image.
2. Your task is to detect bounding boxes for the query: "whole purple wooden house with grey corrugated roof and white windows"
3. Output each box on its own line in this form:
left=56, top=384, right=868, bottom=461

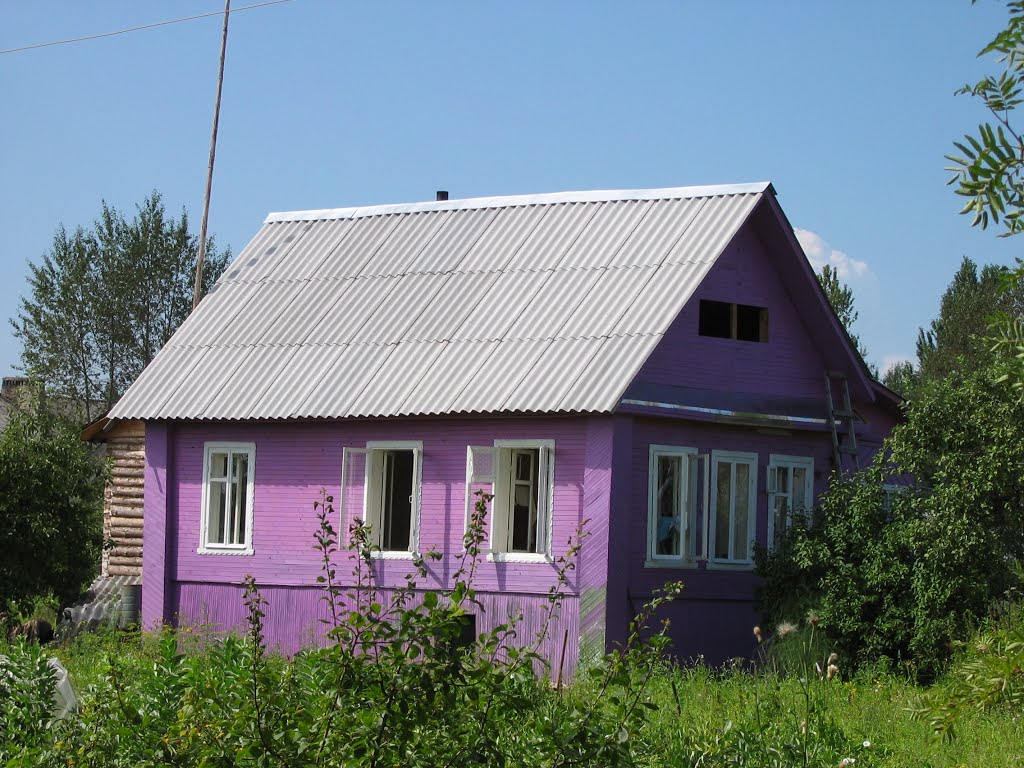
left=111, top=183, right=898, bottom=673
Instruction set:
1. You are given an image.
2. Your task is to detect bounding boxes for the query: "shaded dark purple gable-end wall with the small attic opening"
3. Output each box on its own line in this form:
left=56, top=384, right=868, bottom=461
left=607, top=211, right=895, bottom=664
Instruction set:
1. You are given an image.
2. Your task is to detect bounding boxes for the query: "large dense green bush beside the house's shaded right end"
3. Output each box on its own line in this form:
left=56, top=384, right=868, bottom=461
left=758, top=367, right=1024, bottom=678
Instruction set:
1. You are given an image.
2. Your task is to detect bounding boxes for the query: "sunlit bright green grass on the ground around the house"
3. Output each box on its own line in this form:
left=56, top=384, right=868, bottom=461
left=0, top=629, right=1024, bottom=768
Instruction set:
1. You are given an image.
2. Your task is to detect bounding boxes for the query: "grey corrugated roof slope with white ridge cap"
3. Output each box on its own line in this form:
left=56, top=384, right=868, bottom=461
left=111, top=183, right=769, bottom=420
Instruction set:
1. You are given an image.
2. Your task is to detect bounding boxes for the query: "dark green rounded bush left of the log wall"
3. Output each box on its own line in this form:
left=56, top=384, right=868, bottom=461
left=0, top=392, right=105, bottom=610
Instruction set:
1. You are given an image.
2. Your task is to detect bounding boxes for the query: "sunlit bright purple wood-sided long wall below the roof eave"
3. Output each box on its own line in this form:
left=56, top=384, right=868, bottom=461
left=159, top=417, right=598, bottom=670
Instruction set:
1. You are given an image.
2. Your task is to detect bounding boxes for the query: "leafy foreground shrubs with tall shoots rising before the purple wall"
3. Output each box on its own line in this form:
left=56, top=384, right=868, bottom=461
left=0, top=498, right=884, bottom=768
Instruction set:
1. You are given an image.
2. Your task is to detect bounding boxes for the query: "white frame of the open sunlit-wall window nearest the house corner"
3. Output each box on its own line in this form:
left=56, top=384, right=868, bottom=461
left=466, top=439, right=555, bottom=562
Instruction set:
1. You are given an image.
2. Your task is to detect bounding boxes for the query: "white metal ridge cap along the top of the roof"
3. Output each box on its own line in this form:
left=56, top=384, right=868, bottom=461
left=263, top=181, right=771, bottom=224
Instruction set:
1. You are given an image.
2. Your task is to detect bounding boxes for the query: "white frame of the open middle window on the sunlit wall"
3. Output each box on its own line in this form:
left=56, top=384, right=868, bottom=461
left=352, top=440, right=423, bottom=560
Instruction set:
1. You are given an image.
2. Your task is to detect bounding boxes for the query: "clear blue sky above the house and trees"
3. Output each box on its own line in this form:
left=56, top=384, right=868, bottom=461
left=0, top=0, right=1020, bottom=375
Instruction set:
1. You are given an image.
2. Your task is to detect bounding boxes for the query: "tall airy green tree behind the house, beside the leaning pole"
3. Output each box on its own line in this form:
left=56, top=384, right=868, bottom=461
left=11, top=191, right=230, bottom=420
